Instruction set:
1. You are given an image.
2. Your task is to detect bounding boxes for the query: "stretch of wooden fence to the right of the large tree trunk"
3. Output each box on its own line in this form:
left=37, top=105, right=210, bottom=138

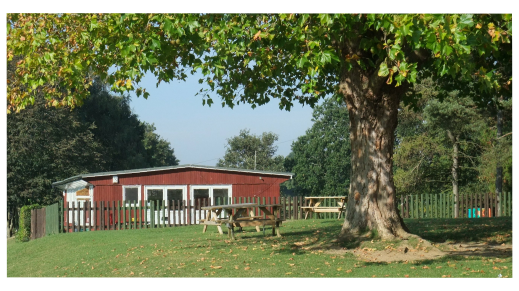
left=398, top=192, right=513, bottom=218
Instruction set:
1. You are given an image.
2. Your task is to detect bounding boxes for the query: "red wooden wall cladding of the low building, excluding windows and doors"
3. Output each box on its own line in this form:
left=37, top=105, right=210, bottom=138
left=84, top=169, right=288, bottom=201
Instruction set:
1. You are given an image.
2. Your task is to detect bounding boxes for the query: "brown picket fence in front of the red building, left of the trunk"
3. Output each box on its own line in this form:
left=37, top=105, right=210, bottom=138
left=58, top=196, right=324, bottom=233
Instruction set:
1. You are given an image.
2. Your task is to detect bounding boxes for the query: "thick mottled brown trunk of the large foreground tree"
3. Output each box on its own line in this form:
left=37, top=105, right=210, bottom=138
left=340, top=70, right=410, bottom=240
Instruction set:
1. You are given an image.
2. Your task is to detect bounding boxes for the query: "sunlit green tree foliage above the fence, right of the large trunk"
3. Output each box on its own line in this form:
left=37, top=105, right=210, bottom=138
left=394, top=79, right=512, bottom=195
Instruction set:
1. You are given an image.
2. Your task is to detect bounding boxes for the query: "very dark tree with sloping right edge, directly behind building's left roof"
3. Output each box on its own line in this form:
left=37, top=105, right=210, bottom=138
left=77, top=80, right=178, bottom=171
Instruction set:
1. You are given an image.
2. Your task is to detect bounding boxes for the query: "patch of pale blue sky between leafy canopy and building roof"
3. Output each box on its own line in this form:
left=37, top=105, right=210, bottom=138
left=130, top=71, right=320, bottom=166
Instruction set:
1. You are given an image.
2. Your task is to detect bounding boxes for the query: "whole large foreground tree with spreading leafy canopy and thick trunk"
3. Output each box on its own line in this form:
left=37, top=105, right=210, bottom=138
left=6, top=14, right=513, bottom=239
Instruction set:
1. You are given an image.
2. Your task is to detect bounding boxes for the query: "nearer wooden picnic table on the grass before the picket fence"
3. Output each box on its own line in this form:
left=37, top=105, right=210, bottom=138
left=200, top=203, right=282, bottom=239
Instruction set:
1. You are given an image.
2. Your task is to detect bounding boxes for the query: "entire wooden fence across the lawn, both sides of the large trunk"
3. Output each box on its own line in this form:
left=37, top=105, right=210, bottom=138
left=31, top=192, right=513, bottom=239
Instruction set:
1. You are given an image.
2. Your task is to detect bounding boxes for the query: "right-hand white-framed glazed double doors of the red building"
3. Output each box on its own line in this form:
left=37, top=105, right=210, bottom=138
left=190, top=185, right=232, bottom=224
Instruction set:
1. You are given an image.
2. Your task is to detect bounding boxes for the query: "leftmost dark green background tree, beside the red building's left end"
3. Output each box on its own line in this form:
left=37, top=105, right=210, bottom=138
left=6, top=99, right=104, bottom=237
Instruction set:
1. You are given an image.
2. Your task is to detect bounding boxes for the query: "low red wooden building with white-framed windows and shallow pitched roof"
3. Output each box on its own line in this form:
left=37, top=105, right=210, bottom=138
left=52, top=165, right=293, bottom=227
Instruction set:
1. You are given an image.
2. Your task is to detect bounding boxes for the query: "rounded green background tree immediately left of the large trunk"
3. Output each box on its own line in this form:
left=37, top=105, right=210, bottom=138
left=285, top=99, right=351, bottom=196
